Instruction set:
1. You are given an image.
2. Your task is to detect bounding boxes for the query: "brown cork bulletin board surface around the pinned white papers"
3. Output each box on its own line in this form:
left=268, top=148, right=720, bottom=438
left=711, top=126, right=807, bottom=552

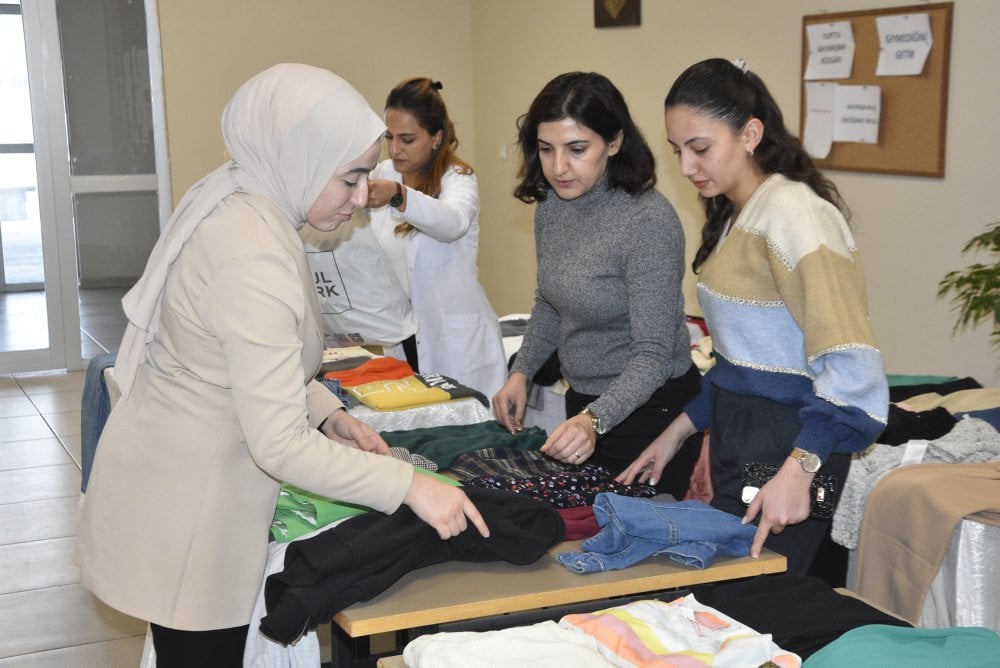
left=799, top=2, right=954, bottom=177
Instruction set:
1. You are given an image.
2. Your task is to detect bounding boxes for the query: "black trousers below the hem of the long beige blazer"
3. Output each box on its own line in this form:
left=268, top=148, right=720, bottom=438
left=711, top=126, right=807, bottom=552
left=149, top=624, right=250, bottom=668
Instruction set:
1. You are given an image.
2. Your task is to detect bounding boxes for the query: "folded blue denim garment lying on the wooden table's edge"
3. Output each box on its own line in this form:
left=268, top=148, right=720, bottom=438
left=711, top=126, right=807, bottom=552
left=556, top=493, right=756, bottom=573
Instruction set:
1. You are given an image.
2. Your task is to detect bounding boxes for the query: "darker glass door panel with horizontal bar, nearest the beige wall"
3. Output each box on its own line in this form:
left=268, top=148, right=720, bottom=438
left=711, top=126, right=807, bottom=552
left=55, top=0, right=163, bottom=357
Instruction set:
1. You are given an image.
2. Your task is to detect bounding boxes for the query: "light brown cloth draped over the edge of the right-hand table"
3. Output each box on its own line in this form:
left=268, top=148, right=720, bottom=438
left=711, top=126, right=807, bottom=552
left=857, top=462, right=1000, bottom=624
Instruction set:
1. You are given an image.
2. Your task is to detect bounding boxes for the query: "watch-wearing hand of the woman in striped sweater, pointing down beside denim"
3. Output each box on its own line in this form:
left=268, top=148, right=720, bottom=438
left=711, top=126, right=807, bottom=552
left=743, top=457, right=815, bottom=559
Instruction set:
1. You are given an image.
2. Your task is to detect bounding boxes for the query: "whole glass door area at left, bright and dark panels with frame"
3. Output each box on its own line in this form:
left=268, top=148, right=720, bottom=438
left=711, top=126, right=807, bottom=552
left=0, top=0, right=170, bottom=373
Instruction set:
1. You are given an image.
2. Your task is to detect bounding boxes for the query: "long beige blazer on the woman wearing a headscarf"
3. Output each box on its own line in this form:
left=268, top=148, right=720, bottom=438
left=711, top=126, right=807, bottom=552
left=76, top=193, right=413, bottom=630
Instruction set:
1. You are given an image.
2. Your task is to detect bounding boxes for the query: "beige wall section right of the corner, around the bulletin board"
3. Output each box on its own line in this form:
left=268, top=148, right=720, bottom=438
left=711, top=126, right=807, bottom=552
left=472, top=0, right=1000, bottom=385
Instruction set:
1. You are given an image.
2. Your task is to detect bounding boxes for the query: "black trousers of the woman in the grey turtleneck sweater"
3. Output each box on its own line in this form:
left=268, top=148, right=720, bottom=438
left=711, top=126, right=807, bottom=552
left=566, top=364, right=702, bottom=500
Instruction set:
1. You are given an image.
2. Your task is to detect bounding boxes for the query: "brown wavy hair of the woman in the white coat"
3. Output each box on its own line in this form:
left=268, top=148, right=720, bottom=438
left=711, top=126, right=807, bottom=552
left=385, top=77, right=472, bottom=235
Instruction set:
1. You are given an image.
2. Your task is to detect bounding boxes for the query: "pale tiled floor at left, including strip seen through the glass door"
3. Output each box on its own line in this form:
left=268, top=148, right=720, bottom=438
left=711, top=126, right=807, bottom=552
left=0, top=291, right=338, bottom=668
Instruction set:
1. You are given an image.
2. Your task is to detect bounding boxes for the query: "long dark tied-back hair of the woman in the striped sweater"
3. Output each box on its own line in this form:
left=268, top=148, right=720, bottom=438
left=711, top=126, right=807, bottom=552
left=664, top=58, right=850, bottom=272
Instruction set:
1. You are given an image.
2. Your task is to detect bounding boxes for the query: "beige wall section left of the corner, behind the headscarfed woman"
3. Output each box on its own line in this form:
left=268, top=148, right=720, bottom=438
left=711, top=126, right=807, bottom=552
left=158, top=0, right=475, bottom=203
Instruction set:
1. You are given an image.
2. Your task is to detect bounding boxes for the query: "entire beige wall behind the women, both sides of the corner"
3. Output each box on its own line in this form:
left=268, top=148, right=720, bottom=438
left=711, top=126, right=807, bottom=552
left=159, top=0, right=1000, bottom=386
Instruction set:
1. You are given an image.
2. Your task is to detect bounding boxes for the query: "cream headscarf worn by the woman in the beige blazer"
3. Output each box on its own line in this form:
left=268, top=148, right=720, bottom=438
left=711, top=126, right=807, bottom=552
left=115, top=63, right=385, bottom=399
